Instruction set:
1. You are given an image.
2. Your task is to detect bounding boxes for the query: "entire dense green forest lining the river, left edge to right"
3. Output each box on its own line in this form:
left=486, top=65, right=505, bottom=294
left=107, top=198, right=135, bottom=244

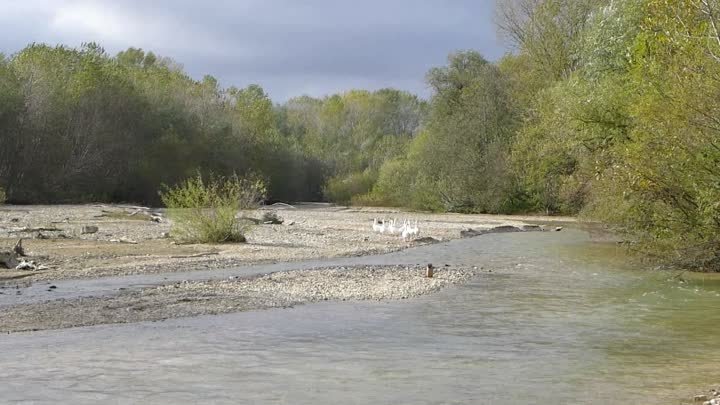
left=0, top=0, right=720, bottom=270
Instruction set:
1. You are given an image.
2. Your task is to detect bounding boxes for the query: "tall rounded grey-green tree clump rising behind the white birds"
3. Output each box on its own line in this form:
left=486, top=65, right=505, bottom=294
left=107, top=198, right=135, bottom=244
left=373, top=51, right=517, bottom=212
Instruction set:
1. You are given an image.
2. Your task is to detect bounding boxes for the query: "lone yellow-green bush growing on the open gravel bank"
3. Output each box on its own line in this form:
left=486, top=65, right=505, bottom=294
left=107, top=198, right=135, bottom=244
left=160, top=173, right=265, bottom=243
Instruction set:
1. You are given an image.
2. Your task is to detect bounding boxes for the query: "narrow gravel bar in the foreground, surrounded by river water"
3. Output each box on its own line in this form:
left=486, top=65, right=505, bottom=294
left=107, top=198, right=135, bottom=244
left=0, top=266, right=478, bottom=333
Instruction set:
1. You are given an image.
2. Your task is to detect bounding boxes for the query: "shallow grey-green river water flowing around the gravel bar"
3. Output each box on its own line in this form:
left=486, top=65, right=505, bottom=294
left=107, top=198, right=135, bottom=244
left=0, top=230, right=720, bottom=404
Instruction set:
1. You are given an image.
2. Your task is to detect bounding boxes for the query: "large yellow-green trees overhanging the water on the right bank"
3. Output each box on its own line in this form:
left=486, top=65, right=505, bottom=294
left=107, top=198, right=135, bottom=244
left=501, top=0, right=720, bottom=270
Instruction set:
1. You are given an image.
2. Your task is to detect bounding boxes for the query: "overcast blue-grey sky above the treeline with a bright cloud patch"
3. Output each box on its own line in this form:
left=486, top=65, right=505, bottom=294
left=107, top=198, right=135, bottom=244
left=0, top=0, right=504, bottom=101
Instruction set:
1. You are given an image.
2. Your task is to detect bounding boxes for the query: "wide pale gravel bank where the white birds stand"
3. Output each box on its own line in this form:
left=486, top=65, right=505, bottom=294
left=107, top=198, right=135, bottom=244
left=0, top=205, right=573, bottom=283
